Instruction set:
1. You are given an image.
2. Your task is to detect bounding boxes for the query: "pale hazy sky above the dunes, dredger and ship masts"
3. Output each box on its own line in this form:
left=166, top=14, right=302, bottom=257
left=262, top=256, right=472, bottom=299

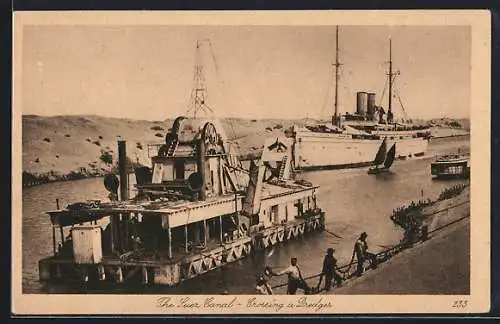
left=22, top=25, right=471, bottom=120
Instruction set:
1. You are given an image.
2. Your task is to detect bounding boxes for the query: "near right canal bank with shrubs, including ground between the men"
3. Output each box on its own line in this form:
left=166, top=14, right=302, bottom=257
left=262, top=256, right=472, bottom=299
left=272, top=183, right=470, bottom=294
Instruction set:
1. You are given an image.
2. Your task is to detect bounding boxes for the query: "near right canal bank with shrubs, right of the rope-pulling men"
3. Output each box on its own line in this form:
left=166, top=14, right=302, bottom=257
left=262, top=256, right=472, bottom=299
left=331, top=184, right=470, bottom=295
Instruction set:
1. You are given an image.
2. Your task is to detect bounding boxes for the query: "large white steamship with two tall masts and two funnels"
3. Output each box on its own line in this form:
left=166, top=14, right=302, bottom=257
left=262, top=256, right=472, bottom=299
left=289, top=27, right=430, bottom=170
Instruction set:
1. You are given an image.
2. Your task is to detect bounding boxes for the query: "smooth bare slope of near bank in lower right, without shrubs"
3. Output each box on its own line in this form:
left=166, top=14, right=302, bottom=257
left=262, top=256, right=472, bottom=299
left=332, top=219, right=470, bottom=295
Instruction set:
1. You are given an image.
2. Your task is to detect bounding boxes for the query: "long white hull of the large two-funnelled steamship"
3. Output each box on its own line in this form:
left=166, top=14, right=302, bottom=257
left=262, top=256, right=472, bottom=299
left=294, top=131, right=428, bottom=170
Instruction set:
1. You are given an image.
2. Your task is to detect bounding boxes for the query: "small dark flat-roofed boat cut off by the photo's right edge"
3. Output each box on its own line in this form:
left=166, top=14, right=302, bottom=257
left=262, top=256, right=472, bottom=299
left=431, top=152, right=470, bottom=178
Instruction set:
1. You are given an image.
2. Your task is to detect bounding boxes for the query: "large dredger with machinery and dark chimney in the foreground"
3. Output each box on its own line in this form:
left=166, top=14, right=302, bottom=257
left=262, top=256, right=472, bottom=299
left=39, top=121, right=324, bottom=286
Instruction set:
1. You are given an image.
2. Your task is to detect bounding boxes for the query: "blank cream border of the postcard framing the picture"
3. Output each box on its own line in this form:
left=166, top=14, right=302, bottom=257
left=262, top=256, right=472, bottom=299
left=12, top=10, right=491, bottom=315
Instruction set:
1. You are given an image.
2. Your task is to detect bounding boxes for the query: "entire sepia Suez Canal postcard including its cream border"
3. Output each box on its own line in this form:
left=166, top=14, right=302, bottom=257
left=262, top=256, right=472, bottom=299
left=12, top=10, right=490, bottom=315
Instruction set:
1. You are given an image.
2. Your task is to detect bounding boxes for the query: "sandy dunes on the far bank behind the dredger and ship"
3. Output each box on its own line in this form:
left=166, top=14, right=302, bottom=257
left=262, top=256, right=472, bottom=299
left=22, top=115, right=464, bottom=185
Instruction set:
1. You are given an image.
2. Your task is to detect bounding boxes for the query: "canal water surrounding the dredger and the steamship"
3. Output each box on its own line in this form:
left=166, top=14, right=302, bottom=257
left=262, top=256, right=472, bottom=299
left=22, top=137, right=469, bottom=294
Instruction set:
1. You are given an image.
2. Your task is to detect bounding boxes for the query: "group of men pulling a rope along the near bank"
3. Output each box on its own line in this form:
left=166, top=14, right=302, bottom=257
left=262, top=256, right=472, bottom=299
left=256, top=232, right=377, bottom=295
